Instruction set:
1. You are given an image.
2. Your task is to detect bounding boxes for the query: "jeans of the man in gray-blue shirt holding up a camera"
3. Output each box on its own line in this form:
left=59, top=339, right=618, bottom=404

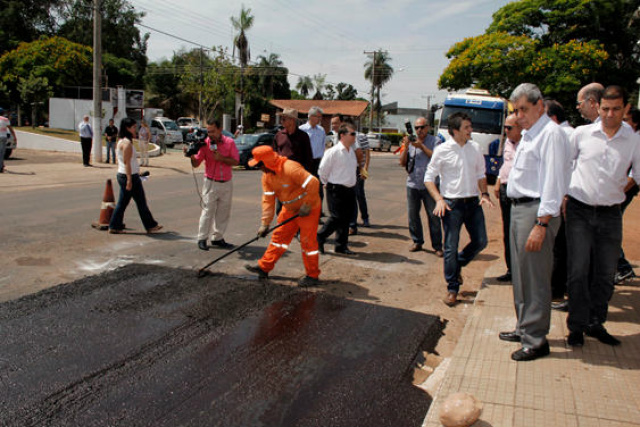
left=407, top=187, right=442, bottom=251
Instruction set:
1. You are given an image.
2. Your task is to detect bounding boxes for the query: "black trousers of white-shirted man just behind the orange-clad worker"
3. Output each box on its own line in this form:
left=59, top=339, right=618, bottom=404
left=318, top=183, right=356, bottom=251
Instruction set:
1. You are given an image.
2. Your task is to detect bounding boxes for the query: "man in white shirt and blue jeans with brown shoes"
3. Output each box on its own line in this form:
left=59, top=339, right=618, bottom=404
left=424, top=113, right=493, bottom=307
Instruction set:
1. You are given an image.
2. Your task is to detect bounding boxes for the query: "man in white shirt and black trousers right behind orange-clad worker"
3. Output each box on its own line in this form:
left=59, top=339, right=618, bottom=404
left=318, top=123, right=358, bottom=255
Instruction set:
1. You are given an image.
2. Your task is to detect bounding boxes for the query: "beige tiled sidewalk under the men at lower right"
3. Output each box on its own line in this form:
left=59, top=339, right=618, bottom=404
left=424, top=262, right=640, bottom=427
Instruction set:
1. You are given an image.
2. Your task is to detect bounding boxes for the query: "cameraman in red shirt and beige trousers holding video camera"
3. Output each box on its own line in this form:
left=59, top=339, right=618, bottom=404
left=184, top=120, right=240, bottom=251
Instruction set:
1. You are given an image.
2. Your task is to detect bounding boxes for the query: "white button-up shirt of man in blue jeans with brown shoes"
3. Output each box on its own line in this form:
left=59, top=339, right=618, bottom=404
left=424, top=139, right=485, bottom=199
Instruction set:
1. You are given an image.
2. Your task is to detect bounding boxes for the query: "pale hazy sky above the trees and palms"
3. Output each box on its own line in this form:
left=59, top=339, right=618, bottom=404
left=129, top=0, right=509, bottom=108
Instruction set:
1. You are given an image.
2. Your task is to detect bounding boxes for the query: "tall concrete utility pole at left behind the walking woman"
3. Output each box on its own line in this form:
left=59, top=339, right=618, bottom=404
left=91, top=0, right=102, bottom=163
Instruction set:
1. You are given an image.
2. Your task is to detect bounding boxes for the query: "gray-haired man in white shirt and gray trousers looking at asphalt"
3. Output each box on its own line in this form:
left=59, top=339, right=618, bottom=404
left=499, top=83, right=569, bottom=361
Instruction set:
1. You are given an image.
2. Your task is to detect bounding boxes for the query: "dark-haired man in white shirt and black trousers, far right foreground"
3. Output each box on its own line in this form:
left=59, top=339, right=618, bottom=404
left=565, top=86, right=640, bottom=347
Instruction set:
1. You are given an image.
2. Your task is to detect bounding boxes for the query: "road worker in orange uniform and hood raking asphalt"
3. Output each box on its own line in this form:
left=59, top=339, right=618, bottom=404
left=245, top=146, right=322, bottom=287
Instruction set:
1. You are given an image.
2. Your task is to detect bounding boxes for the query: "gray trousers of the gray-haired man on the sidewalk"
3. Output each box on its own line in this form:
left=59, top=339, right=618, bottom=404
left=509, top=202, right=560, bottom=348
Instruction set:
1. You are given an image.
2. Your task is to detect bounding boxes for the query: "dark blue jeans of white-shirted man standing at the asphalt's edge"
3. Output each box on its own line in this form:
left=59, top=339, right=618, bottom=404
left=442, top=197, right=487, bottom=292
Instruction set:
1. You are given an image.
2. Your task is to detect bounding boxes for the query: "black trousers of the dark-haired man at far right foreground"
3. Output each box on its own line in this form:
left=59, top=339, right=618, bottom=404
left=566, top=197, right=622, bottom=332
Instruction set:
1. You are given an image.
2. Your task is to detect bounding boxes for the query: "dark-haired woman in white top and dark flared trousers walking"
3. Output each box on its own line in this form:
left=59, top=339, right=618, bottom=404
left=109, top=117, right=162, bottom=234
